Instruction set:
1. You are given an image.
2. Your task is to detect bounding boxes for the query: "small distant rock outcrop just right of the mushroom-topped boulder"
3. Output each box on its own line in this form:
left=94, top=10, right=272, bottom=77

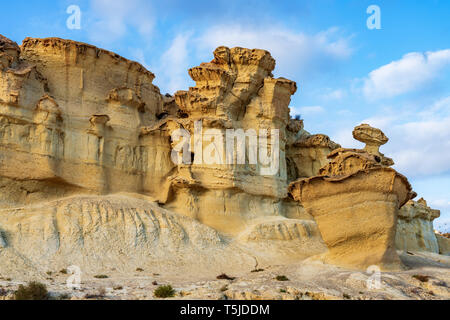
left=395, top=198, right=440, bottom=253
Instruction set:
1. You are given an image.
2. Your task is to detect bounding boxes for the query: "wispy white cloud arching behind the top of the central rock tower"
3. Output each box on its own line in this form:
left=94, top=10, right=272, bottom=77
left=154, top=25, right=353, bottom=94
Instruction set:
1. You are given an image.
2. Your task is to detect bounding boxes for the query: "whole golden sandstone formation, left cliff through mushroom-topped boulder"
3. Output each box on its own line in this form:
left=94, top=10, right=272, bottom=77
left=0, top=36, right=446, bottom=273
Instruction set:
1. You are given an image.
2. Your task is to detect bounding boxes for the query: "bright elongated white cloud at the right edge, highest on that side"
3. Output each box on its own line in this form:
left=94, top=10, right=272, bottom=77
left=363, top=49, right=450, bottom=99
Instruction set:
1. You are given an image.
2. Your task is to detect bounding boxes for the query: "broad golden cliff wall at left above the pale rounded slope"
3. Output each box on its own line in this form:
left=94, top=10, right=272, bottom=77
left=0, top=38, right=173, bottom=205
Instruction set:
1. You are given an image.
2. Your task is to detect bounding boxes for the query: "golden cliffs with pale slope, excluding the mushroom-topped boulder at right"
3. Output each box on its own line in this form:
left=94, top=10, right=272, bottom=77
left=0, top=37, right=333, bottom=276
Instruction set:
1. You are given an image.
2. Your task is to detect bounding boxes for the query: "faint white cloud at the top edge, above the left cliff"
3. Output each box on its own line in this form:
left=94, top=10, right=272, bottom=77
left=88, top=0, right=155, bottom=44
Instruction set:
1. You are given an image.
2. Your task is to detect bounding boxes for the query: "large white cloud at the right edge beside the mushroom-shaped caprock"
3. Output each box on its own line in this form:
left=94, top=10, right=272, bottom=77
left=344, top=97, right=450, bottom=178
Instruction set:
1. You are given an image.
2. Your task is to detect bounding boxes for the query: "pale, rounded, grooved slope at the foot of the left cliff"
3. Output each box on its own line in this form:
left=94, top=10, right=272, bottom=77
left=0, top=194, right=264, bottom=277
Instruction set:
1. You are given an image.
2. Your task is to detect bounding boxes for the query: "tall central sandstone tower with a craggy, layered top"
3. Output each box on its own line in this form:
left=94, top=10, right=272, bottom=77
left=160, top=47, right=308, bottom=234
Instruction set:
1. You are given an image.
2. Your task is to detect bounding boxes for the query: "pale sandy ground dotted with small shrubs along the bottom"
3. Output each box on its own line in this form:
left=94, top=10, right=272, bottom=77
left=0, top=252, right=450, bottom=300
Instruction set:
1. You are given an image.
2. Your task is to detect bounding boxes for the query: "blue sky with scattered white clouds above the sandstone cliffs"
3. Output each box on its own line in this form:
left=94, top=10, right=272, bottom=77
left=0, top=0, right=450, bottom=231
